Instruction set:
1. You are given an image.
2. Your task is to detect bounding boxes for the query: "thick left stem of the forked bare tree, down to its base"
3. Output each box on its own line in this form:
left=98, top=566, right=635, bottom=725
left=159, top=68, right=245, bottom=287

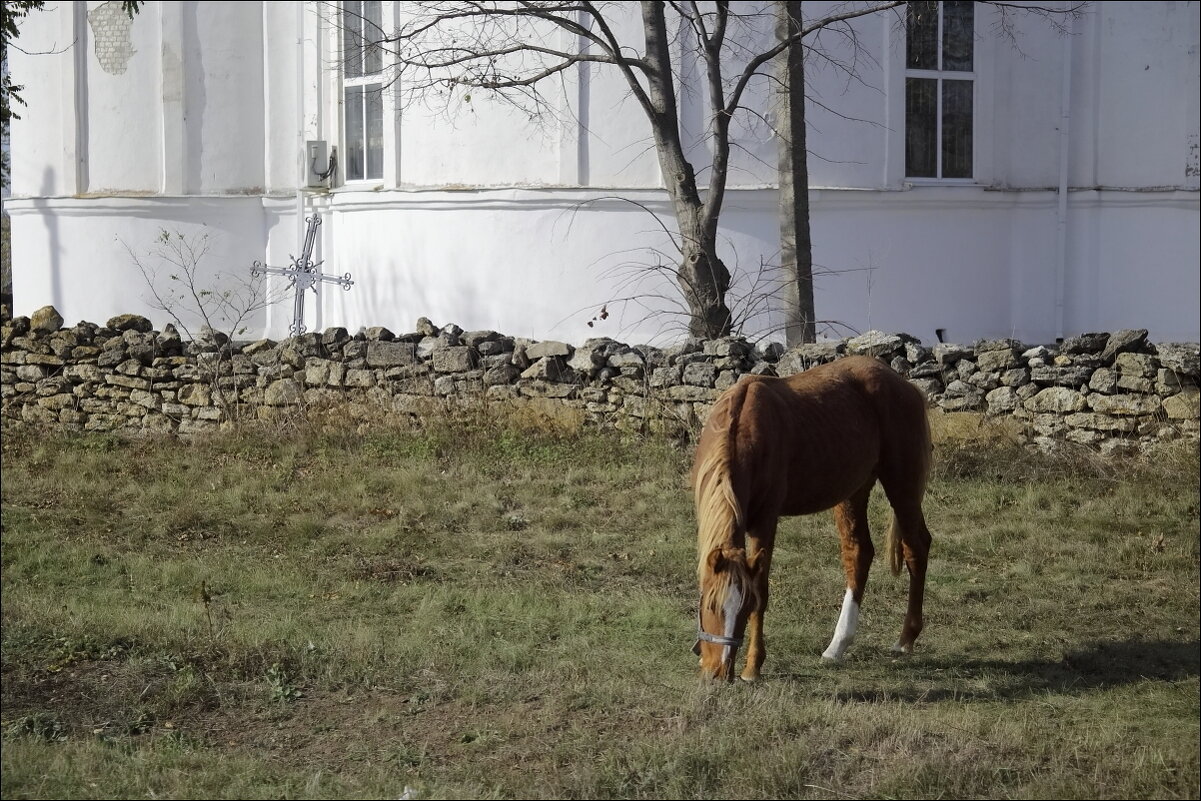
left=643, top=0, right=733, bottom=339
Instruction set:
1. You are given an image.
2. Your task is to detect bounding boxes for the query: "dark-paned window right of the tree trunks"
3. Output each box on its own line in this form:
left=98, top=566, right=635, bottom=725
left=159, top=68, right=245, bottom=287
left=904, top=2, right=975, bottom=178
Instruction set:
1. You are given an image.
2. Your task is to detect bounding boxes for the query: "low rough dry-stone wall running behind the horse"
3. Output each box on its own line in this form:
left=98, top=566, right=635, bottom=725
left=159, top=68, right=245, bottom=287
left=0, top=306, right=1201, bottom=452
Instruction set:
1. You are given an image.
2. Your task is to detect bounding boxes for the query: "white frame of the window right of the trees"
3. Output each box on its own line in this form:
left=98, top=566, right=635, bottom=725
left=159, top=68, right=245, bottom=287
left=895, top=0, right=986, bottom=185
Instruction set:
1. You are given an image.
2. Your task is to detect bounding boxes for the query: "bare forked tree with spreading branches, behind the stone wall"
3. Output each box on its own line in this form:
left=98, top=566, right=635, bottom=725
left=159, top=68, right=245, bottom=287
left=335, top=0, right=898, bottom=336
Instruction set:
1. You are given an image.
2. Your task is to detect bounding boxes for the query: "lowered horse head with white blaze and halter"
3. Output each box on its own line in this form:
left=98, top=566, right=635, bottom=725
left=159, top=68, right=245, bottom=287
left=692, top=545, right=758, bottom=681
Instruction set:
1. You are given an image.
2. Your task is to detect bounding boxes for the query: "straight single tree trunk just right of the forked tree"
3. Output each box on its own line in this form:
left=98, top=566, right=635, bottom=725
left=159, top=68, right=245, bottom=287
left=776, top=0, right=817, bottom=346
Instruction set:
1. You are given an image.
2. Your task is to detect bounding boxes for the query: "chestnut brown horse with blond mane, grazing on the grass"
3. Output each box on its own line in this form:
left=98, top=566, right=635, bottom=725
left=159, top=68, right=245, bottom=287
left=692, top=357, right=931, bottom=681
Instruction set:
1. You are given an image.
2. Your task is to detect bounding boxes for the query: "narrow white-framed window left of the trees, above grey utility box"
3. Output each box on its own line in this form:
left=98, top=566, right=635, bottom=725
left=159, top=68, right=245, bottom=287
left=341, top=0, right=383, bottom=181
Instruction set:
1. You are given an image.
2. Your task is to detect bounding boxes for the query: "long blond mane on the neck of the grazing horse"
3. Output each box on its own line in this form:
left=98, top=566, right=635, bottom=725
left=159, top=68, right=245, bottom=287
left=693, top=388, right=746, bottom=575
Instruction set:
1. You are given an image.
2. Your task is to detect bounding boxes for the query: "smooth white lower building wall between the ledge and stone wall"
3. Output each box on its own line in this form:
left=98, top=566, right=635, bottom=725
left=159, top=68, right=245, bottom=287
left=12, top=187, right=1201, bottom=342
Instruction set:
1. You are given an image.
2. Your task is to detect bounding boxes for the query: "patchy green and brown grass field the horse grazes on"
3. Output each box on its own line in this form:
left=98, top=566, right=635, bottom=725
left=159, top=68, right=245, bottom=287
left=0, top=413, right=1201, bottom=799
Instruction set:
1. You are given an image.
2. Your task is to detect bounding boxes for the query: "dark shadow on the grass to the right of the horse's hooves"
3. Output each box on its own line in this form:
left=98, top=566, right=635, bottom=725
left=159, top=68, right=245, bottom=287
left=807, top=640, right=1201, bottom=704
